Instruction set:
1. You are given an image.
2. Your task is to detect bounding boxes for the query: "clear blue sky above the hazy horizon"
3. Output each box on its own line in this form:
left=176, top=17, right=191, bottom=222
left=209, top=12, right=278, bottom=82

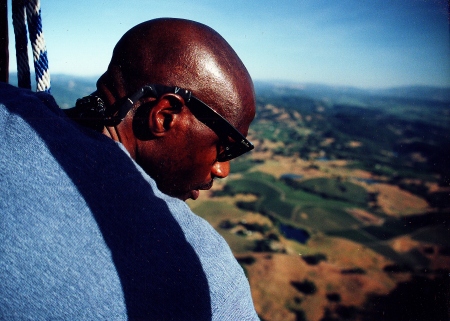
left=8, top=0, right=450, bottom=88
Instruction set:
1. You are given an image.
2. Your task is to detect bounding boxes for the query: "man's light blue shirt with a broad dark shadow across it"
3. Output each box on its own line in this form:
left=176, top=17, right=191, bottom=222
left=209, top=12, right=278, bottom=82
left=0, top=83, right=258, bottom=320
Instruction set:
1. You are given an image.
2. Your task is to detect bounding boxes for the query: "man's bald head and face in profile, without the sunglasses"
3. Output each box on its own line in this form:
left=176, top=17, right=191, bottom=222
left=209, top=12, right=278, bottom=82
left=97, top=19, right=255, bottom=200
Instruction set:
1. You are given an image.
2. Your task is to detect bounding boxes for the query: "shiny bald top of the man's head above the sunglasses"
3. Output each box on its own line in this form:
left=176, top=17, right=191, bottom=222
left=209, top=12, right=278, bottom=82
left=99, top=18, right=254, bottom=126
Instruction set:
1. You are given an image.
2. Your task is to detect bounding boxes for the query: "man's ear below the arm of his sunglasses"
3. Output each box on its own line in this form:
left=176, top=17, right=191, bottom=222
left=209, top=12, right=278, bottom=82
left=148, top=94, right=184, bottom=137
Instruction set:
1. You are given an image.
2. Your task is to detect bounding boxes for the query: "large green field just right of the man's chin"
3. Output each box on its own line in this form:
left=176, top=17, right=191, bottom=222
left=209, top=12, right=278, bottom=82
left=218, top=172, right=365, bottom=231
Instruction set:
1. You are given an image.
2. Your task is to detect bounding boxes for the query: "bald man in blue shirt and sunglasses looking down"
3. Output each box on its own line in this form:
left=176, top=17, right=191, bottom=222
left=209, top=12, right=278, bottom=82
left=0, top=19, right=258, bottom=320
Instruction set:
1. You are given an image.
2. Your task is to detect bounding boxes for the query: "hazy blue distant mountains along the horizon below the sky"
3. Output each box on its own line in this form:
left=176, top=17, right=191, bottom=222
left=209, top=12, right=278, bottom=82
left=10, top=74, right=450, bottom=108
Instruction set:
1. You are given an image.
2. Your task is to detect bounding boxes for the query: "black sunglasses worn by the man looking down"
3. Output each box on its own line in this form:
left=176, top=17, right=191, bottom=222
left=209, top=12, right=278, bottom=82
left=108, top=85, right=254, bottom=162
